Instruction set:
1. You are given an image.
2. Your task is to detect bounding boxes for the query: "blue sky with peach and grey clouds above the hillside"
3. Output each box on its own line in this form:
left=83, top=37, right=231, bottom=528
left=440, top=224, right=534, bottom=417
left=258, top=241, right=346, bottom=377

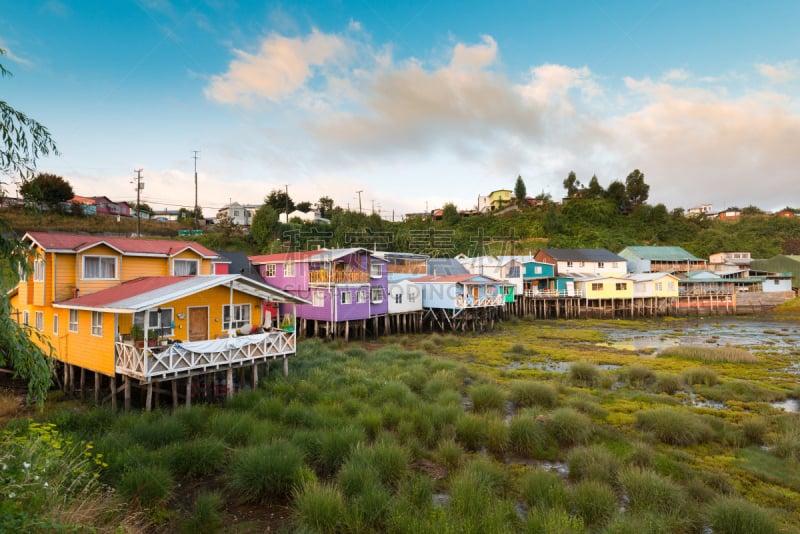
left=0, top=0, right=800, bottom=219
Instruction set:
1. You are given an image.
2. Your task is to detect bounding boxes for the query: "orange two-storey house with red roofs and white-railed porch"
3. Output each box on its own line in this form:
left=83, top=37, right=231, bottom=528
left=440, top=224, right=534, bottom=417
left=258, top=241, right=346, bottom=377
left=11, top=232, right=306, bottom=410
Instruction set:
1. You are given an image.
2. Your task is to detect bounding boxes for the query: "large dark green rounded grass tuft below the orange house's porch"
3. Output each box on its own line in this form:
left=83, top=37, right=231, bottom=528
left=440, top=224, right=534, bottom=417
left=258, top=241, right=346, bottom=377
left=229, top=441, right=313, bottom=502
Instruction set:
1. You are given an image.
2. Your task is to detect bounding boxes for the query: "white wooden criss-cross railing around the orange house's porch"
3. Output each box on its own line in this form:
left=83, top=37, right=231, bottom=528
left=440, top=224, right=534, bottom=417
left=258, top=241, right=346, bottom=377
left=115, top=332, right=296, bottom=382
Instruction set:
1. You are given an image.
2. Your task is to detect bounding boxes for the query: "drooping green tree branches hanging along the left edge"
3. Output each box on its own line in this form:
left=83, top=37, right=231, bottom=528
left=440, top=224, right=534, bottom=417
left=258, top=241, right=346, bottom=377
left=0, top=49, right=58, bottom=407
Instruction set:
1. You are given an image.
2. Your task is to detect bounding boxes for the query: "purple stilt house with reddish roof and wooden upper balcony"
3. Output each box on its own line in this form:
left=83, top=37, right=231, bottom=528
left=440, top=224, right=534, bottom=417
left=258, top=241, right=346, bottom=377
left=250, top=248, right=389, bottom=323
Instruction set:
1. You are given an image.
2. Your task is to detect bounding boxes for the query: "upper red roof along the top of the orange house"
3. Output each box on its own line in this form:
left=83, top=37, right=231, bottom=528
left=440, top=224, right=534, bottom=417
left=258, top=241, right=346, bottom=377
left=27, top=232, right=217, bottom=258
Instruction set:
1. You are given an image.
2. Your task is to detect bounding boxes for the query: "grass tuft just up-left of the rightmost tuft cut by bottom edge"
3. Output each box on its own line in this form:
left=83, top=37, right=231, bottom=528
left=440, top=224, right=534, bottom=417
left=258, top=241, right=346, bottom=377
left=619, top=467, right=685, bottom=515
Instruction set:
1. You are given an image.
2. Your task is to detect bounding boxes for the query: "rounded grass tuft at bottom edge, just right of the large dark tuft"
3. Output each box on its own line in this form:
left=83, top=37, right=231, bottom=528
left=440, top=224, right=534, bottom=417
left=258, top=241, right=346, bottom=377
left=294, top=484, right=345, bottom=534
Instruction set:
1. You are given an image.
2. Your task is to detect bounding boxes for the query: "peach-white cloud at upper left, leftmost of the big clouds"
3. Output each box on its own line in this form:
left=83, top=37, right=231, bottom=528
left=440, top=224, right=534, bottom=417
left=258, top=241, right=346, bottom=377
left=205, top=30, right=347, bottom=104
